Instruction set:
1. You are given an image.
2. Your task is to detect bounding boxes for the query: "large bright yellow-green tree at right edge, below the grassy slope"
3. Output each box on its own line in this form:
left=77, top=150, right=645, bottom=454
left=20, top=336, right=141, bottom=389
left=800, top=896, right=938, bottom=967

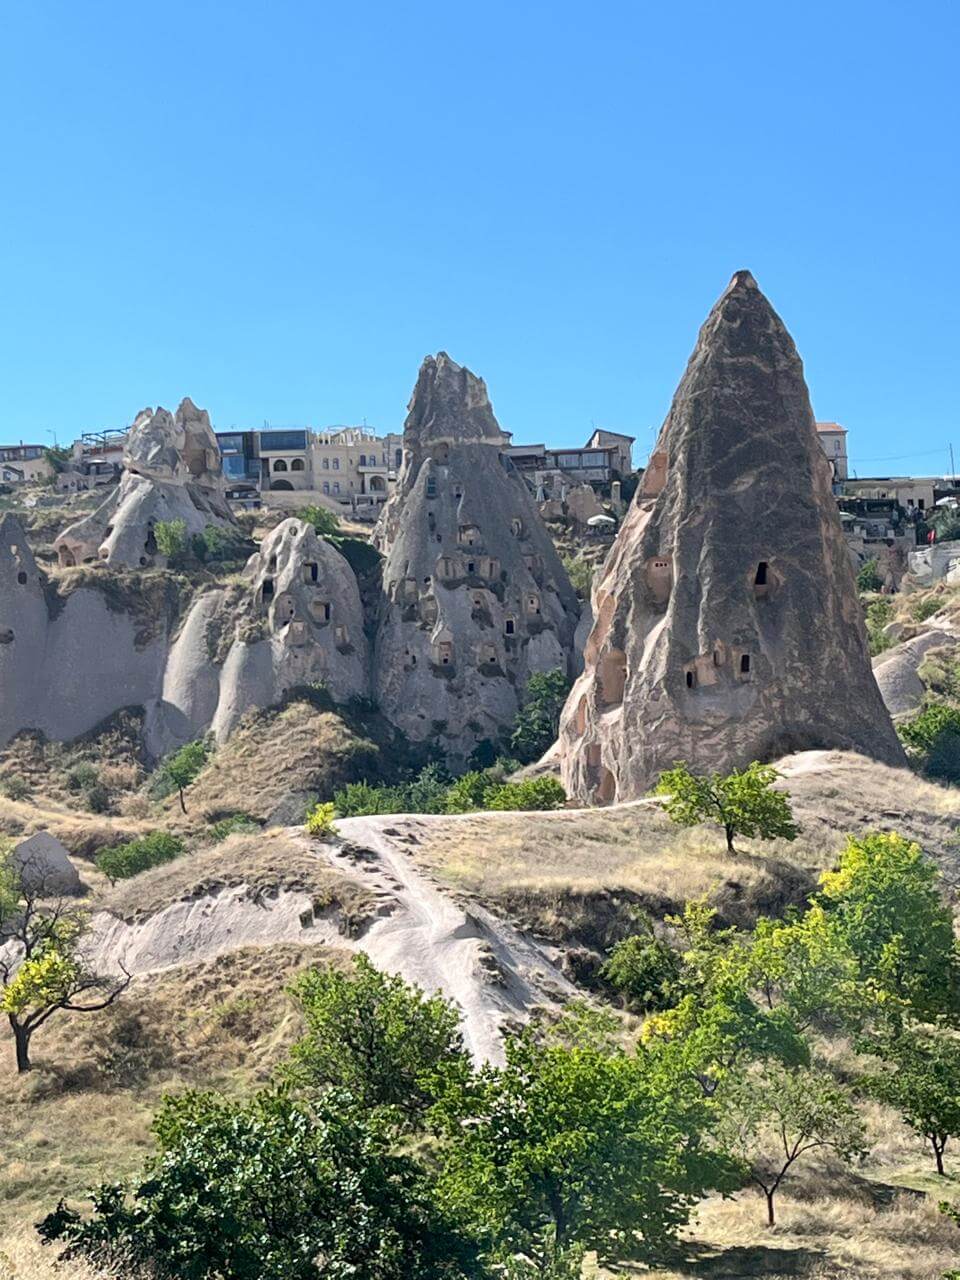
left=815, top=832, right=960, bottom=1020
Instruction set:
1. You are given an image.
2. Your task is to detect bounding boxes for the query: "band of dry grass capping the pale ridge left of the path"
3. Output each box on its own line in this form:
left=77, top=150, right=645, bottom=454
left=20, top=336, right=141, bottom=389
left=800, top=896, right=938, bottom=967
left=96, top=828, right=378, bottom=936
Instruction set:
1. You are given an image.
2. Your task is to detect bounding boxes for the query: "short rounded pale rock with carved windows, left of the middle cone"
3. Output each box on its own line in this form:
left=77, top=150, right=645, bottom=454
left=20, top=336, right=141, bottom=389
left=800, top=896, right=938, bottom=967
left=147, top=518, right=369, bottom=755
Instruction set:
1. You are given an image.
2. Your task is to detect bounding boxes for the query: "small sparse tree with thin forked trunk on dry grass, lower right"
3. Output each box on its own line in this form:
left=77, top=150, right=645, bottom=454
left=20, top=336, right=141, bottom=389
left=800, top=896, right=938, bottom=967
left=726, top=1060, right=864, bottom=1226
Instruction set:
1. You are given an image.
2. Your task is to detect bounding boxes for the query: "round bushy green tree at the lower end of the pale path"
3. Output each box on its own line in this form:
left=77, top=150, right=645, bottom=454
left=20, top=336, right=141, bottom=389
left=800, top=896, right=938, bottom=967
left=289, top=955, right=470, bottom=1129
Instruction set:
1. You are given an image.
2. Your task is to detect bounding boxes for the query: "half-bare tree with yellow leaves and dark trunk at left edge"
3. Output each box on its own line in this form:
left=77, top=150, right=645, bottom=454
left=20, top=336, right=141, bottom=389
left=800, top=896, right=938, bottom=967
left=0, top=855, right=131, bottom=1073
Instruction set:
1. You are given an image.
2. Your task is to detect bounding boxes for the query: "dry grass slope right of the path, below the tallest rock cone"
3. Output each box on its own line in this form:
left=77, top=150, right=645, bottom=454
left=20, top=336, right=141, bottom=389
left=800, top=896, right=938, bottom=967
left=407, top=751, right=960, bottom=945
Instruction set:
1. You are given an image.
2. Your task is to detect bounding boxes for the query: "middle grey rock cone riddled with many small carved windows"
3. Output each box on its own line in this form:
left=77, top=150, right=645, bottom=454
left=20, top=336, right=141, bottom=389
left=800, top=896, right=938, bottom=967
left=374, top=352, right=579, bottom=755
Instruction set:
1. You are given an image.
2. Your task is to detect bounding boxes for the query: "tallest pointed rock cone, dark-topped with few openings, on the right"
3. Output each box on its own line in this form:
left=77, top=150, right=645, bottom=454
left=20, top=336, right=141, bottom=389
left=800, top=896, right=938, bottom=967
left=561, top=271, right=902, bottom=803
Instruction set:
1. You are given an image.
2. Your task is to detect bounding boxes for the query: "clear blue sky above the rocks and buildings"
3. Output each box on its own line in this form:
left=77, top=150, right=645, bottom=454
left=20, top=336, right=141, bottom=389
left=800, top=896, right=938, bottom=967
left=0, top=0, right=960, bottom=475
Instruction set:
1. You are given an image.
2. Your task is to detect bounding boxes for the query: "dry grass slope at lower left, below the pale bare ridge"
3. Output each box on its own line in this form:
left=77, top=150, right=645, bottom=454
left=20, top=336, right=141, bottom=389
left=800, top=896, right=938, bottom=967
left=0, top=945, right=347, bottom=1239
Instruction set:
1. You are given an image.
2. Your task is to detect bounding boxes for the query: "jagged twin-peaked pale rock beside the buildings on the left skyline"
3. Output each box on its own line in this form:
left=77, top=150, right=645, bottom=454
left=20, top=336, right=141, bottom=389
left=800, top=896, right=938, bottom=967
left=56, top=399, right=236, bottom=568
